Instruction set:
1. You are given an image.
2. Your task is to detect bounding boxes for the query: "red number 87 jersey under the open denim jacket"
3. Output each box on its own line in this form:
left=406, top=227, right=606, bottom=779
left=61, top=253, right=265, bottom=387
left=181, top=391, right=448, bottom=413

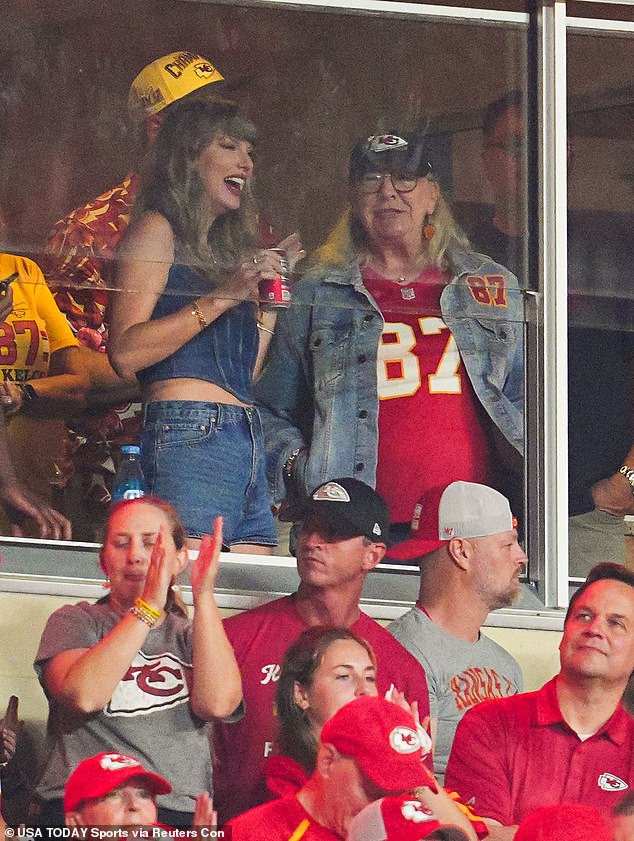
left=362, top=266, right=489, bottom=523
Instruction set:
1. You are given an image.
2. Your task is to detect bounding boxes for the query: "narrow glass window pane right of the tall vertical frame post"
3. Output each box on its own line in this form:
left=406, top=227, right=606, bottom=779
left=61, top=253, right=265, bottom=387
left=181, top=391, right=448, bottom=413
left=568, top=24, right=634, bottom=577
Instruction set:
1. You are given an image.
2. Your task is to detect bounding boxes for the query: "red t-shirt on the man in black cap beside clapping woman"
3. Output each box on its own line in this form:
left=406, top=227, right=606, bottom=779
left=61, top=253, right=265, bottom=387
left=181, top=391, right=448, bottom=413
left=214, top=596, right=431, bottom=824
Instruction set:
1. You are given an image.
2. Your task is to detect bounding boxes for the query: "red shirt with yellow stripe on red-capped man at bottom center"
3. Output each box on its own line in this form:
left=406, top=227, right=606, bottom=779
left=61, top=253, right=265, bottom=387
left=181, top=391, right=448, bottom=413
left=227, top=794, right=340, bottom=841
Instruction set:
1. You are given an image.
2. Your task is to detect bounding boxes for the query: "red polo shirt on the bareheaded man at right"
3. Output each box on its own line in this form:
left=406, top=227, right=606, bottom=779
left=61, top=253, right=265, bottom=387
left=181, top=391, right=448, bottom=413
left=445, top=678, right=634, bottom=826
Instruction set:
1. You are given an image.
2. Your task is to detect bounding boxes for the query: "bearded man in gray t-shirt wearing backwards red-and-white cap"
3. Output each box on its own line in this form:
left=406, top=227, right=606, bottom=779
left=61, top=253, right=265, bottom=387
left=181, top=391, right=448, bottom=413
left=387, top=482, right=527, bottom=781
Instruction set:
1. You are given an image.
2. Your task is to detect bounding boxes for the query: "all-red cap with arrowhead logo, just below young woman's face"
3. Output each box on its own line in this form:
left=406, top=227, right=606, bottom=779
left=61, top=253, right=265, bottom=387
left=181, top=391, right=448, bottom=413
left=321, top=696, right=437, bottom=793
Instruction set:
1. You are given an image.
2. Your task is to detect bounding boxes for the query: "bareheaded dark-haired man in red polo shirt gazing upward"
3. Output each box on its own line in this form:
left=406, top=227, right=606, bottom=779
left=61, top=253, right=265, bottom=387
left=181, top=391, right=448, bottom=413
left=445, top=563, right=634, bottom=839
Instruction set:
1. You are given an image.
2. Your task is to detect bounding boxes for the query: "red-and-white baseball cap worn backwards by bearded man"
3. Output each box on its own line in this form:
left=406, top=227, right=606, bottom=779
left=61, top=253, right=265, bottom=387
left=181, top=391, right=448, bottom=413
left=385, top=482, right=517, bottom=561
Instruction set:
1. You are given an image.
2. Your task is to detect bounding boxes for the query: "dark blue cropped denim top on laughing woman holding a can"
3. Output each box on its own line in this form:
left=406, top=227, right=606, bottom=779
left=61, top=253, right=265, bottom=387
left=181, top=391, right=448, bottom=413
left=137, top=263, right=259, bottom=403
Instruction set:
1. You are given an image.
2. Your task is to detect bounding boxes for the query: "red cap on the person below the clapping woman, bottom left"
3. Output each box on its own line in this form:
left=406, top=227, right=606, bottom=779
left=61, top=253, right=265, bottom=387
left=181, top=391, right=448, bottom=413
left=64, top=753, right=172, bottom=812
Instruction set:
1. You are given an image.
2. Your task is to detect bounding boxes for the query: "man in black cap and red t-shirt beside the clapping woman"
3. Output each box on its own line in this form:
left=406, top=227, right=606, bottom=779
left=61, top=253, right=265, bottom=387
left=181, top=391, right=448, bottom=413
left=214, top=478, right=429, bottom=823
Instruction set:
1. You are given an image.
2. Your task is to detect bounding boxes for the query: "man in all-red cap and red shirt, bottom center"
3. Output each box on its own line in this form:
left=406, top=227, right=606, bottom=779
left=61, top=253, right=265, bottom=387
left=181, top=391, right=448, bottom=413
left=228, top=696, right=437, bottom=841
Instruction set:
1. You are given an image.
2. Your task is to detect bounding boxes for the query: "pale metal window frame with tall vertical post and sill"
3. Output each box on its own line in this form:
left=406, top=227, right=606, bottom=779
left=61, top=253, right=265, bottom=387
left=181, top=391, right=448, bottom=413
left=0, top=0, right=634, bottom=616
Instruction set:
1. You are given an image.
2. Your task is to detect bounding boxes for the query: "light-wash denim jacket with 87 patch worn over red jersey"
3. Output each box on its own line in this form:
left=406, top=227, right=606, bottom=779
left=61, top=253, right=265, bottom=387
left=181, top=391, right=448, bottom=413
left=255, top=246, right=524, bottom=503
